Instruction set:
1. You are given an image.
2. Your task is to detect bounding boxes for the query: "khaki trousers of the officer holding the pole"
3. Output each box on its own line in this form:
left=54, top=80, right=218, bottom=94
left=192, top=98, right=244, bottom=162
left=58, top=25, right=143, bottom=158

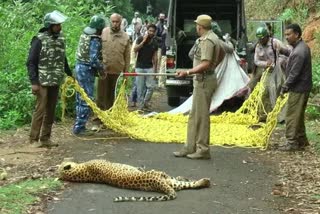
left=184, top=74, right=217, bottom=153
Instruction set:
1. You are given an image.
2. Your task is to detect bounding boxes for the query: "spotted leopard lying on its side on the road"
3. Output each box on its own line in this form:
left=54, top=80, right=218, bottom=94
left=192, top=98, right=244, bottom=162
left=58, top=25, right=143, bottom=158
left=58, top=160, right=210, bottom=202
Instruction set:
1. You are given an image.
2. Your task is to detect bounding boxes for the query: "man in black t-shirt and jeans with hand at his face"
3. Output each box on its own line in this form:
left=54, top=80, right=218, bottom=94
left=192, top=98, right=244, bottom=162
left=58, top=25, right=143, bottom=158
left=134, top=24, right=158, bottom=110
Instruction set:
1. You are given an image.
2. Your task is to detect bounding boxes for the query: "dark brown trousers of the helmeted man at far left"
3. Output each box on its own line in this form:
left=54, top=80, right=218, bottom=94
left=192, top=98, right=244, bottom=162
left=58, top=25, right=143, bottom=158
left=30, top=86, right=59, bottom=141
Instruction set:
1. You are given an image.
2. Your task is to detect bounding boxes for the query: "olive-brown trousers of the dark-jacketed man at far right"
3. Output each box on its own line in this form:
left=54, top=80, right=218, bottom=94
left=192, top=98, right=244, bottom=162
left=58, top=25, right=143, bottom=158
left=286, top=92, right=309, bottom=145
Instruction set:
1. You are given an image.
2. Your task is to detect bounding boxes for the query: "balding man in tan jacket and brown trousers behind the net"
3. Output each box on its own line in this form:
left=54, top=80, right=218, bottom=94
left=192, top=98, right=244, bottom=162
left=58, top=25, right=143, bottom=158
left=92, top=13, right=131, bottom=131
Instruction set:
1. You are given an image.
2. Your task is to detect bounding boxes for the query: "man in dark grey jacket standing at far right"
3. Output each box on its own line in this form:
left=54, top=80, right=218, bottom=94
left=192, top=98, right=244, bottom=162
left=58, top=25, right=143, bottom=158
left=279, top=24, right=312, bottom=151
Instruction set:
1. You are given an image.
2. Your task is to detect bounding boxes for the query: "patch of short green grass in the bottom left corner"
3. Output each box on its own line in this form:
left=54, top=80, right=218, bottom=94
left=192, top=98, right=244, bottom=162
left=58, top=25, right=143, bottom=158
left=0, top=178, right=62, bottom=214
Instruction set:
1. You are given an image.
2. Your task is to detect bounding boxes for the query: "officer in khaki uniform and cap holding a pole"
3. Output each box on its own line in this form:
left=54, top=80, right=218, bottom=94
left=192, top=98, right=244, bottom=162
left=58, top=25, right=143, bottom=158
left=173, top=15, right=225, bottom=159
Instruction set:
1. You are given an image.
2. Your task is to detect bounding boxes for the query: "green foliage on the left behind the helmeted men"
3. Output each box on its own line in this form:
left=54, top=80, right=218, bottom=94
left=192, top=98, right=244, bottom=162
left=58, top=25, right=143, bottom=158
left=0, top=0, right=133, bottom=129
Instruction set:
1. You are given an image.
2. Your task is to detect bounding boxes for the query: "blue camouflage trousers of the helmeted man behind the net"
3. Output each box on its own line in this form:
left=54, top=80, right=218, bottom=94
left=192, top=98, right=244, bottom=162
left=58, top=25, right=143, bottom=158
left=73, top=64, right=95, bottom=133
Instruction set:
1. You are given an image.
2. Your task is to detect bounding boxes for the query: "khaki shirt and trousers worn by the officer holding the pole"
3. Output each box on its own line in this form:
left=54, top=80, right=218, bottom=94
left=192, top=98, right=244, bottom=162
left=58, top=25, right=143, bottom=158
left=184, top=31, right=224, bottom=154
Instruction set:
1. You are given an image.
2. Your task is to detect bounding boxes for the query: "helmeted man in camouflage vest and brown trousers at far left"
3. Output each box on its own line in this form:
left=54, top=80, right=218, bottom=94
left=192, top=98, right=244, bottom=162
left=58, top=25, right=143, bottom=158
left=27, top=11, right=72, bottom=147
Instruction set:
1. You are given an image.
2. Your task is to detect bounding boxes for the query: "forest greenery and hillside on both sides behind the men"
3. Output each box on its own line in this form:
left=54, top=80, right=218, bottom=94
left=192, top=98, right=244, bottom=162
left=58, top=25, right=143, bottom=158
left=0, top=0, right=320, bottom=130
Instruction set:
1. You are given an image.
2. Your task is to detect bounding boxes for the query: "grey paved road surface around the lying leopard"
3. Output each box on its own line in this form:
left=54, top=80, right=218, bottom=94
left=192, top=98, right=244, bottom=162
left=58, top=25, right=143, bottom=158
left=48, top=140, right=280, bottom=214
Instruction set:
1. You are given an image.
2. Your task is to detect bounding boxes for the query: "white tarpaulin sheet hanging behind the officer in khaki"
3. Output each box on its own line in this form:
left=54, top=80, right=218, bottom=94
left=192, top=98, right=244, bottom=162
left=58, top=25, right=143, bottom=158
left=169, top=53, right=249, bottom=114
